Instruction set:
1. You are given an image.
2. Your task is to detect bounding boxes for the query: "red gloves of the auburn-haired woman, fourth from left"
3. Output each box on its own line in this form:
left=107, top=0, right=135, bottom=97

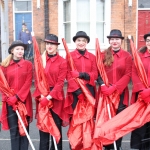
left=101, top=85, right=116, bottom=96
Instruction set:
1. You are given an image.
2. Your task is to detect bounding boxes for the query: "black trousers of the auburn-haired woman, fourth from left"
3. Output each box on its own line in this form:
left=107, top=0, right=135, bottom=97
left=105, top=92, right=126, bottom=150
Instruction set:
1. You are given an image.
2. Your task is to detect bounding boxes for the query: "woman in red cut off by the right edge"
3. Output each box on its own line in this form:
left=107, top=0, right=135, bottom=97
left=130, top=33, right=150, bottom=150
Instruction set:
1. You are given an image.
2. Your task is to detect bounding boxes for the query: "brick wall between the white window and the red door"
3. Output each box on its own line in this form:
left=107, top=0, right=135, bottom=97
left=111, top=0, right=137, bottom=49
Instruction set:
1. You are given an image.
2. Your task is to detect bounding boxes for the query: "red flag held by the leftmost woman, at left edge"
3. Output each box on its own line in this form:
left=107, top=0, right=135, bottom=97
left=0, top=68, right=28, bottom=136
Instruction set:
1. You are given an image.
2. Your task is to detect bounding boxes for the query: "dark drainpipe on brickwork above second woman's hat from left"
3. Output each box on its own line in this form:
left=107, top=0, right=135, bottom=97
left=44, top=0, right=49, bottom=37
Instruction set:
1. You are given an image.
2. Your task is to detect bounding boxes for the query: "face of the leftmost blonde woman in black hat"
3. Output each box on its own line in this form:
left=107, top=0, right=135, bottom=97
left=11, top=46, right=24, bottom=60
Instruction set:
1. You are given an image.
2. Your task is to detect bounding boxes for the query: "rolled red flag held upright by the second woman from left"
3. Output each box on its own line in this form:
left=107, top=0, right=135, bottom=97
left=32, top=36, right=60, bottom=143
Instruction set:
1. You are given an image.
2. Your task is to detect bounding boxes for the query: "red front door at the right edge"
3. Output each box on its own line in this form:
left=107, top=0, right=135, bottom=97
left=138, top=10, right=150, bottom=49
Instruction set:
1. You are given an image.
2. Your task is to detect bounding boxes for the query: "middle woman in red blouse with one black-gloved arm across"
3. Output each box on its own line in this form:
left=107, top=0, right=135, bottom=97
left=65, top=31, right=98, bottom=113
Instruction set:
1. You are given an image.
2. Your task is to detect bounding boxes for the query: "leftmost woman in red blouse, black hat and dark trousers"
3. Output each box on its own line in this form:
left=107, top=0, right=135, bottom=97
left=1, top=40, right=33, bottom=150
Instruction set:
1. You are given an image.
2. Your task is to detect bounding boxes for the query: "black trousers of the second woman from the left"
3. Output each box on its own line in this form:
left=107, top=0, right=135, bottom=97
left=39, top=109, right=62, bottom=150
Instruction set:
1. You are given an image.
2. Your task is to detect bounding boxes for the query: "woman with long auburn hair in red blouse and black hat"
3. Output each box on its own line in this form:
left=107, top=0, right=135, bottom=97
left=97, top=29, right=132, bottom=150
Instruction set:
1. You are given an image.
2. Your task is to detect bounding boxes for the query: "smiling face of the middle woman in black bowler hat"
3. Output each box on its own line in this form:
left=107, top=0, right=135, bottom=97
left=75, top=37, right=87, bottom=51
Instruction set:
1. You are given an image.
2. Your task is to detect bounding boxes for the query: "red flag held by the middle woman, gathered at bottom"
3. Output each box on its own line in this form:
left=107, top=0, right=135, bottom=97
left=62, top=39, right=95, bottom=150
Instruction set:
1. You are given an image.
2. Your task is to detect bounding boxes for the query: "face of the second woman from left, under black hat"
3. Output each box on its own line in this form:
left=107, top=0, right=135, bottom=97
left=46, top=43, right=58, bottom=55
